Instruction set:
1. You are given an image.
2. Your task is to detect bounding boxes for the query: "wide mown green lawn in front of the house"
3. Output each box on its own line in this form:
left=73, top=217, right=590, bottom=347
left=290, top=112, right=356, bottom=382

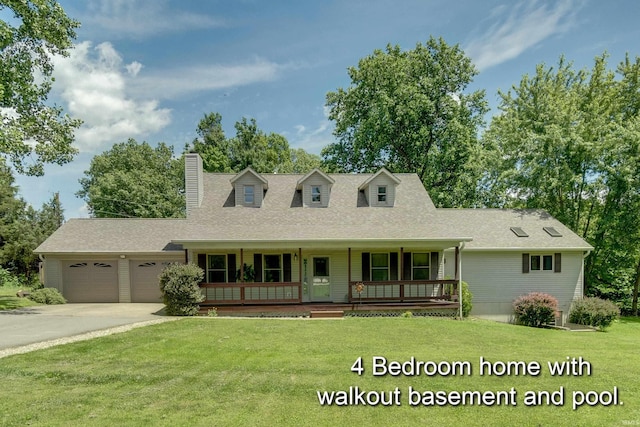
left=0, top=317, right=640, bottom=426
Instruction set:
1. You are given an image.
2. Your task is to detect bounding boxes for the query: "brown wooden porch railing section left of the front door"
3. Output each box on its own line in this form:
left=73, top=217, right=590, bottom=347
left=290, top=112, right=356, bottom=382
left=200, top=282, right=302, bottom=305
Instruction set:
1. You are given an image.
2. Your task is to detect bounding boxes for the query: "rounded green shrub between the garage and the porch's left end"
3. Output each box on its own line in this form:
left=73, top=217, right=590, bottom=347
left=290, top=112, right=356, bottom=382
left=159, top=263, right=204, bottom=316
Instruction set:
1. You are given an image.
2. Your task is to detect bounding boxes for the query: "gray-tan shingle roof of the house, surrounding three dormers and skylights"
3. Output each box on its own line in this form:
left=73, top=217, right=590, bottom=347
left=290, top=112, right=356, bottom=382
left=36, top=173, right=591, bottom=254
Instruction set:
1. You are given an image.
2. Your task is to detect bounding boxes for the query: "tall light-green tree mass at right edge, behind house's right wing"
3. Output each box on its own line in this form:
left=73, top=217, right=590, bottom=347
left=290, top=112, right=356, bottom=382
left=484, top=55, right=640, bottom=310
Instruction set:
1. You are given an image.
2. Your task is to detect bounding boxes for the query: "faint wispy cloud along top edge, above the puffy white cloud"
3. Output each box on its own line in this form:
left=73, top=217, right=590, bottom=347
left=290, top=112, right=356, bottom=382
left=81, top=0, right=225, bottom=39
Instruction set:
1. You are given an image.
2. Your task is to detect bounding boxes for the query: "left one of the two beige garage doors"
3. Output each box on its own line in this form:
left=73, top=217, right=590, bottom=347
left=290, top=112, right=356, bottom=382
left=62, top=260, right=118, bottom=302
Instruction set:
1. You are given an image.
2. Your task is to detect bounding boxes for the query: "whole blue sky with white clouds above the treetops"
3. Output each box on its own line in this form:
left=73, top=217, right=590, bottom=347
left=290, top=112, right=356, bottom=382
left=6, top=0, right=640, bottom=218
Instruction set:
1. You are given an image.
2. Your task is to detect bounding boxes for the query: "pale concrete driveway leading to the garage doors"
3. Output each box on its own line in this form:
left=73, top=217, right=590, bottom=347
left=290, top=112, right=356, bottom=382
left=0, top=303, right=175, bottom=356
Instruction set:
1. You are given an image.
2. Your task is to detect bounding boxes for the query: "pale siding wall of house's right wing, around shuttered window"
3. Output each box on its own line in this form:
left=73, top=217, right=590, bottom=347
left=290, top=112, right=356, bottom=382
left=445, top=251, right=583, bottom=322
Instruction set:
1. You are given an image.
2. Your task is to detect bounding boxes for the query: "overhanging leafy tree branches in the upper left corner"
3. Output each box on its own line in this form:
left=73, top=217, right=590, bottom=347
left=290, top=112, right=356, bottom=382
left=0, top=0, right=81, bottom=175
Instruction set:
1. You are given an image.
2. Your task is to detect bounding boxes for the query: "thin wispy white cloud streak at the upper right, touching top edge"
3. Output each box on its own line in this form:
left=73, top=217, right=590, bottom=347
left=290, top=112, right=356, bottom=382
left=464, top=0, right=578, bottom=70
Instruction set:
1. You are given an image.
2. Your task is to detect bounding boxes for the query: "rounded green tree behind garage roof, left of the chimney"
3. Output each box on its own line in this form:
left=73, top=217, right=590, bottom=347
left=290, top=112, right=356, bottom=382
left=76, top=139, right=185, bottom=218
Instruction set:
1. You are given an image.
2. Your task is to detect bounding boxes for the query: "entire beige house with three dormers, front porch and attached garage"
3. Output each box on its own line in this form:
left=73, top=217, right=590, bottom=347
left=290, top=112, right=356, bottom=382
left=36, top=154, right=592, bottom=321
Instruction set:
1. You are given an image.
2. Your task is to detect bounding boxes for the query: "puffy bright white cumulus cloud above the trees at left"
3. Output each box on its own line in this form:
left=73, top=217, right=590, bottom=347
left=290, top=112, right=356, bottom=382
left=54, top=42, right=171, bottom=152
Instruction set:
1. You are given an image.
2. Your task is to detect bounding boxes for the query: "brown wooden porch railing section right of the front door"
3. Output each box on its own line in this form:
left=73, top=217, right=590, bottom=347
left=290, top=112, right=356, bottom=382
left=349, top=280, right=458, bottom=303
